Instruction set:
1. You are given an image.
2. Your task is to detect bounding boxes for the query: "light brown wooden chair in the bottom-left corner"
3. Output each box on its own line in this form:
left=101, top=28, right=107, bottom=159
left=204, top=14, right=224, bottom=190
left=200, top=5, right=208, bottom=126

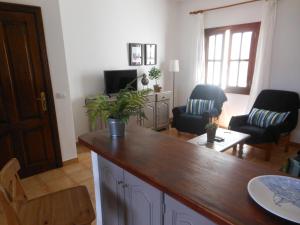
left=0, top=159, right=95, bottom=225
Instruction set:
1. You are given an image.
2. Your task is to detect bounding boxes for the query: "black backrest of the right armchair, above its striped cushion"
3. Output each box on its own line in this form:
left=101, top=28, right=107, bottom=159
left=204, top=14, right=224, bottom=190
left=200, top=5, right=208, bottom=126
left=253, top=90, right=300, bottom=130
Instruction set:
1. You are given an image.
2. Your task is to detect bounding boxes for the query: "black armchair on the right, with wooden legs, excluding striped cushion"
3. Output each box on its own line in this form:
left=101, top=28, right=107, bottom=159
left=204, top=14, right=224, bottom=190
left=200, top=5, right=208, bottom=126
left=229, top=90, right=300, bottom=160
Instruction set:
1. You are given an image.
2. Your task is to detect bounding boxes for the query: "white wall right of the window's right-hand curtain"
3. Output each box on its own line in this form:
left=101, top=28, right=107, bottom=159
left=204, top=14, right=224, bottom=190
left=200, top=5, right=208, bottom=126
left=271, top=0, right=300, bottom=143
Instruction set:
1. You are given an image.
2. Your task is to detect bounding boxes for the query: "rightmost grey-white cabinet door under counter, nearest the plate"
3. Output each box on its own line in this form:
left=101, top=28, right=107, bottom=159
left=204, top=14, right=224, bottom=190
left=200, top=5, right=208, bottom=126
left=164, top=195, right=215, bottom=225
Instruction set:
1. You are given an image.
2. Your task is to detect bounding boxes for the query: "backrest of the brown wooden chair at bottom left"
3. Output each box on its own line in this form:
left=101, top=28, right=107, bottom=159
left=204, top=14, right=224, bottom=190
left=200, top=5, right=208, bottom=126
left=0, top=158, right=27, bottom=209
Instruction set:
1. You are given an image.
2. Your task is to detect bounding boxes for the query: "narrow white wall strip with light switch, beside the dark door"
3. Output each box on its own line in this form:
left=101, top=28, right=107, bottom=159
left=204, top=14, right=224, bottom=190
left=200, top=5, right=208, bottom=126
left=5, top=0, right=77, bottom=161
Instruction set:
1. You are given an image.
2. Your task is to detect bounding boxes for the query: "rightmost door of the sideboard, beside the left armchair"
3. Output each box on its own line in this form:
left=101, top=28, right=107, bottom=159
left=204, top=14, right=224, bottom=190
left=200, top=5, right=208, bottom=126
left=156, top=100, right=169, bottom=129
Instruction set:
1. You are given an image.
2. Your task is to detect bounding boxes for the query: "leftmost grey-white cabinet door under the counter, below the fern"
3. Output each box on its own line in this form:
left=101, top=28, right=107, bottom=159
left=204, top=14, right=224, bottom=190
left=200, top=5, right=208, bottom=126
left=99, top=157, right=125, bottom=225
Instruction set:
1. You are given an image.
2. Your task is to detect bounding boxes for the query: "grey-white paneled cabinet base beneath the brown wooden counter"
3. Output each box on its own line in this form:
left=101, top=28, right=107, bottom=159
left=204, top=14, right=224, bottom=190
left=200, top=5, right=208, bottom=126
left=95, top=156, right=215, bottom=225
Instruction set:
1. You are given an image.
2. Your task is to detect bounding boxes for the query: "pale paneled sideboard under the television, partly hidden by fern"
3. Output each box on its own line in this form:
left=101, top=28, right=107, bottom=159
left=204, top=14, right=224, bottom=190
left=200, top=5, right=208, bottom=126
left=85, top=91, right=172, bottom=130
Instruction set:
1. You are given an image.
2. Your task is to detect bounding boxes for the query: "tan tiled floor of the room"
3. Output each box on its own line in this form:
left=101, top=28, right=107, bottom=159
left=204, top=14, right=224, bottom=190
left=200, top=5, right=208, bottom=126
left=0, top=129, right=300, bottom=225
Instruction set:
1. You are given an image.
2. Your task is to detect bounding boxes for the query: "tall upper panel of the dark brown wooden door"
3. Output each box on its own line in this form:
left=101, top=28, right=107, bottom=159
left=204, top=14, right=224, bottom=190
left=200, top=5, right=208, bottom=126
left=3, top=22, right=39, bottom=120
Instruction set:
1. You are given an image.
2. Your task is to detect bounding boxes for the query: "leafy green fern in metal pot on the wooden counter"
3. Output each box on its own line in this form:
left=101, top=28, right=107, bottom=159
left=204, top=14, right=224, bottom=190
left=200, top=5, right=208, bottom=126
left=86, top=88, right=150, bottom=137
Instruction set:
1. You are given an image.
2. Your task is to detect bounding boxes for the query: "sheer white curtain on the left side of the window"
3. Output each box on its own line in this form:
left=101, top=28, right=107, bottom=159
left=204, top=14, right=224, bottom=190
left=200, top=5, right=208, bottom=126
left=193, top=13, right=205, bottom=84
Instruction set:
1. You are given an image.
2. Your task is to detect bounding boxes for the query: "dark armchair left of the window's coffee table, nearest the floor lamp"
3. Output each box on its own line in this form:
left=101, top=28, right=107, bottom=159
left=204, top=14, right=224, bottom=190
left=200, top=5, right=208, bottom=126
left=172, top=85, right=227, bottom=135
